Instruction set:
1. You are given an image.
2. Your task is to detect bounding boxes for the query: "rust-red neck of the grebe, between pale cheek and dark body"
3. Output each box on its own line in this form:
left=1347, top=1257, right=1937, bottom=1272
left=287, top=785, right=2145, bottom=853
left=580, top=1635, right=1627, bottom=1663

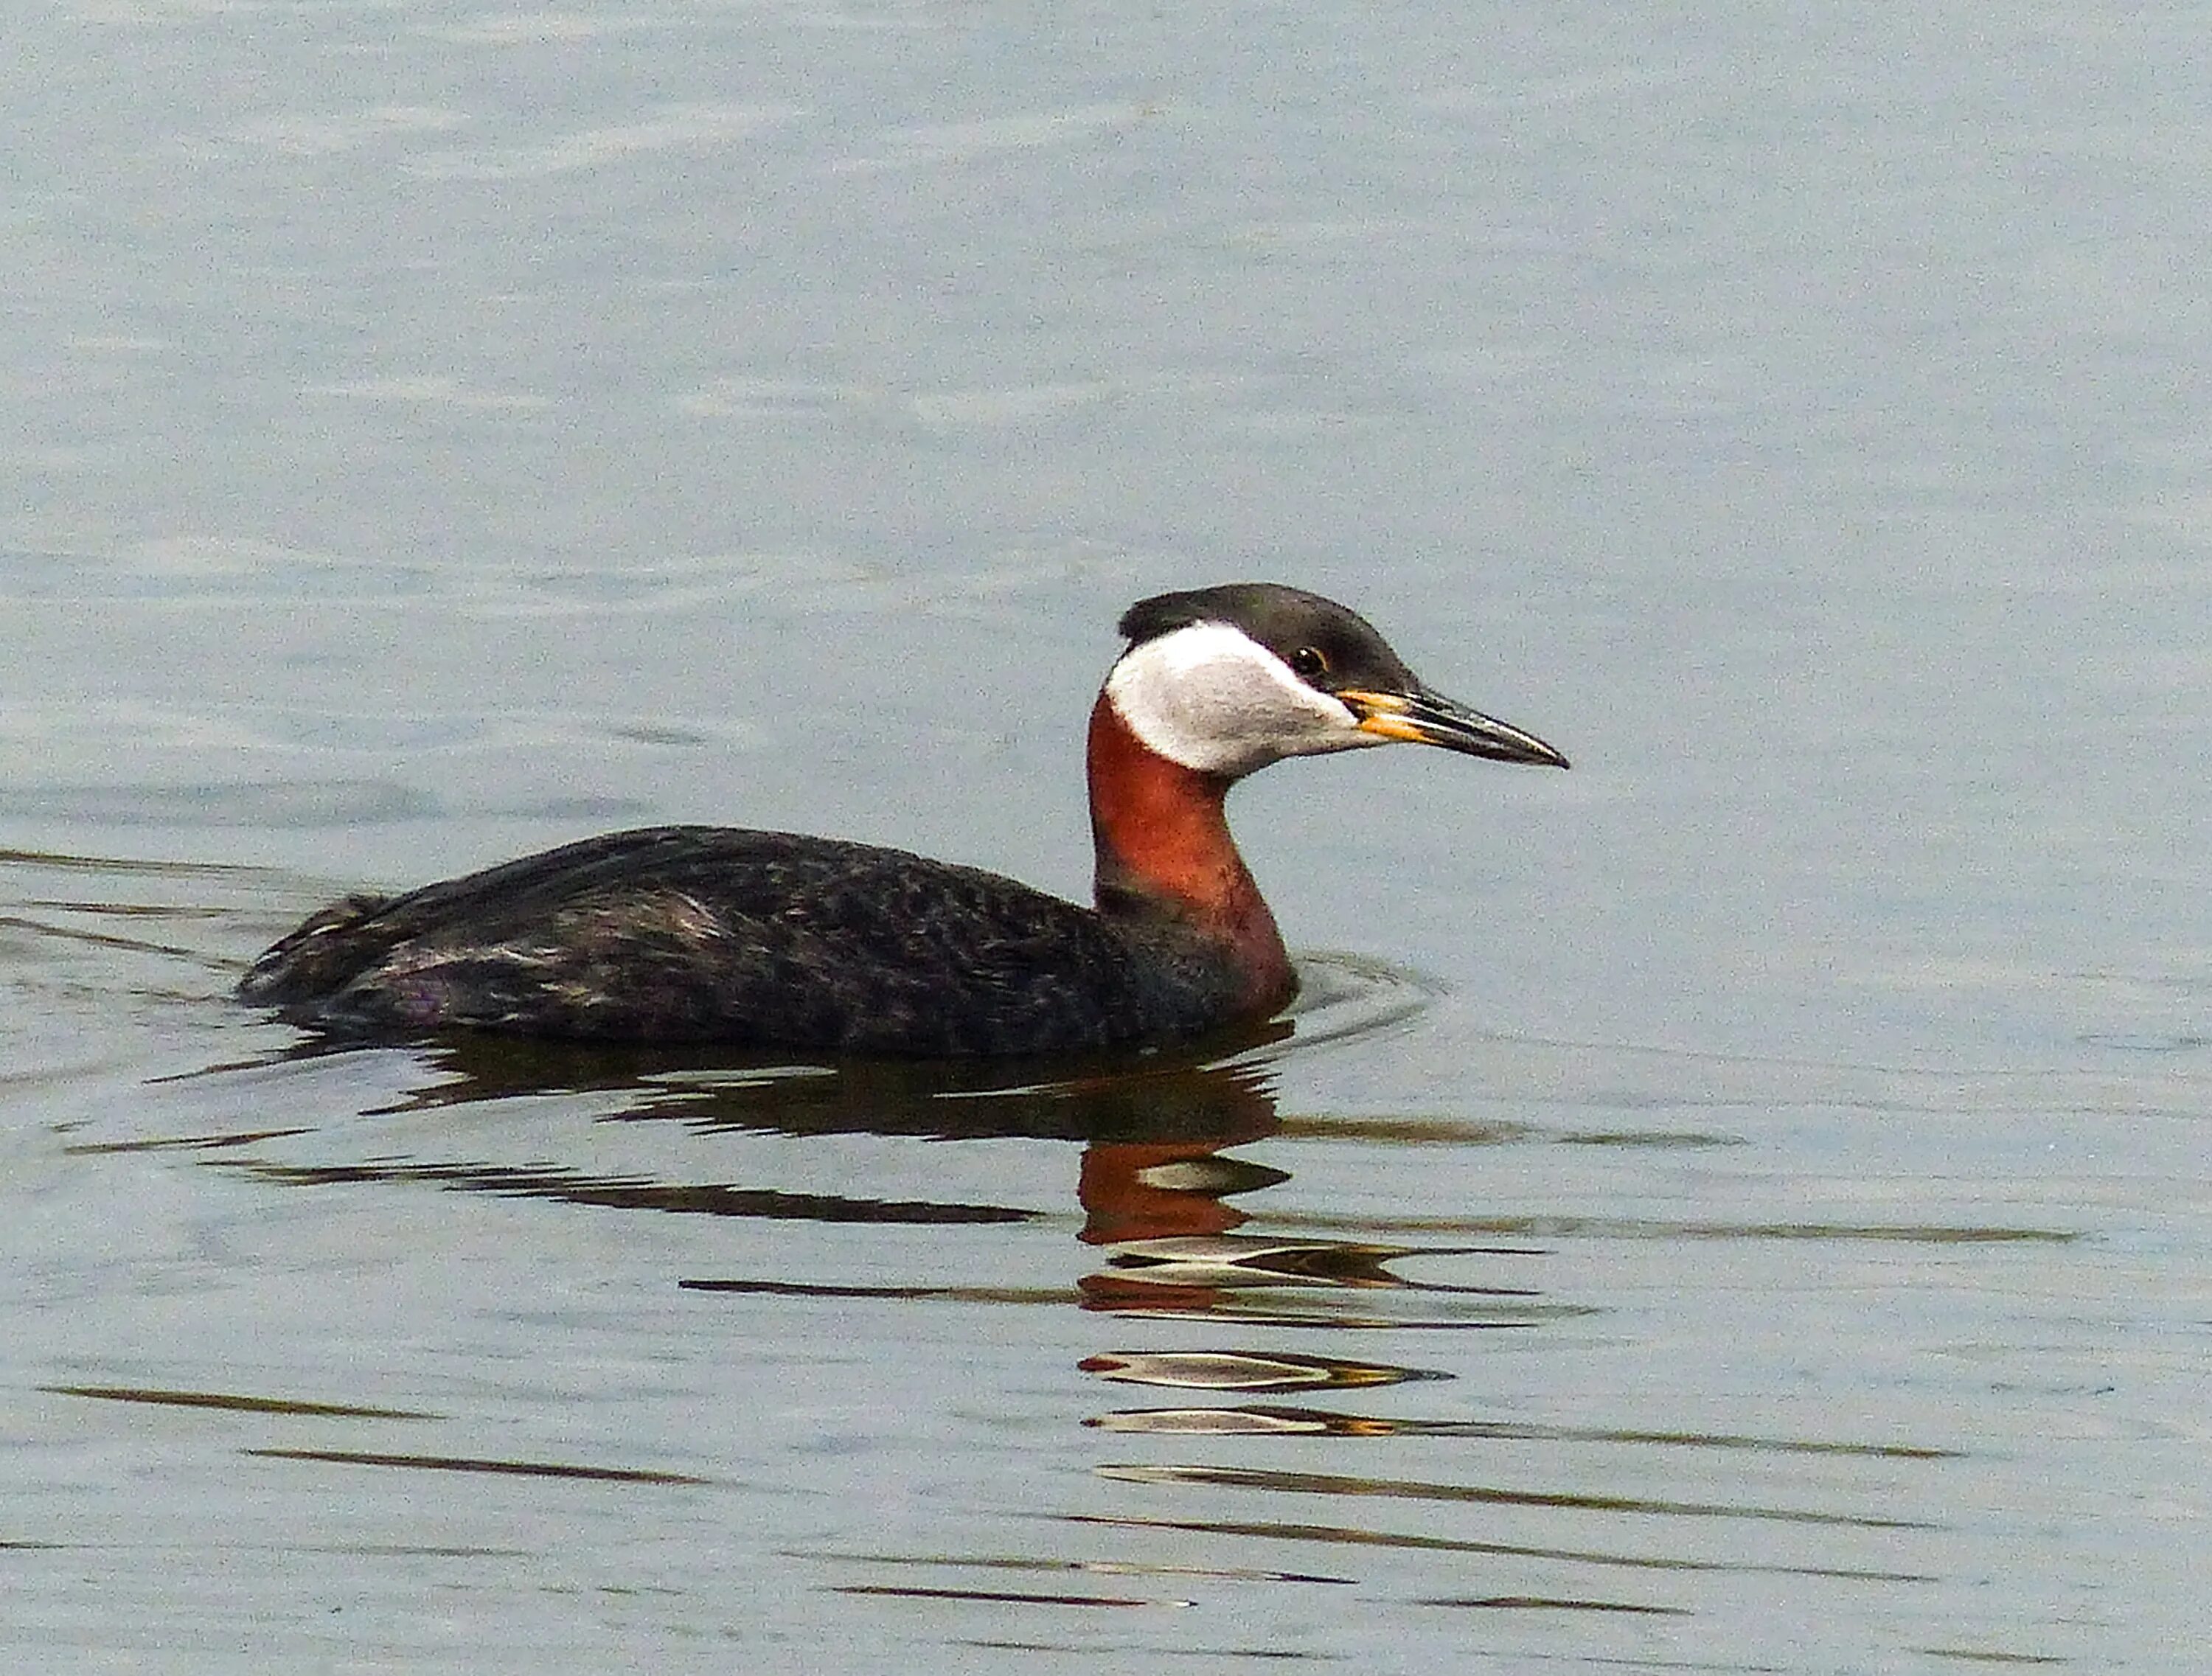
left=1091, top=692, right=1296, bottom=1010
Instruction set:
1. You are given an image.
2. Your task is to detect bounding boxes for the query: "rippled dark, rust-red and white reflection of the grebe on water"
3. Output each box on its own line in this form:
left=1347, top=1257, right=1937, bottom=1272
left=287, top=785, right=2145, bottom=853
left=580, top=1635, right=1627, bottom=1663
left=208, top=999, right=1579, bottom=1459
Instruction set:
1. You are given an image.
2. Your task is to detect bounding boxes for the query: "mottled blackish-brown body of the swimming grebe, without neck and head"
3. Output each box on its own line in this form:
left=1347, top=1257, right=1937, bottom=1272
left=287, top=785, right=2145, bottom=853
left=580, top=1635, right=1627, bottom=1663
left=239, top=827, right=1239, bottom=1057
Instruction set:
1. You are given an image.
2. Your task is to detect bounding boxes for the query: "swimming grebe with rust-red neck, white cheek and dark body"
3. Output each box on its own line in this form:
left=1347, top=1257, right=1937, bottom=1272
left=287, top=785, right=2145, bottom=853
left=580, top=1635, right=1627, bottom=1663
left=239, top=582, right=1566, bottom=1057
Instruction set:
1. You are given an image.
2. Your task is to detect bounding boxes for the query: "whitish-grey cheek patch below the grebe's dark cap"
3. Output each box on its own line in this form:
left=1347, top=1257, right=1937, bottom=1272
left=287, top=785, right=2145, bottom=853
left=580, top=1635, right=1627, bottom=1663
left=1106, top=624, right=1385, bottom=779
